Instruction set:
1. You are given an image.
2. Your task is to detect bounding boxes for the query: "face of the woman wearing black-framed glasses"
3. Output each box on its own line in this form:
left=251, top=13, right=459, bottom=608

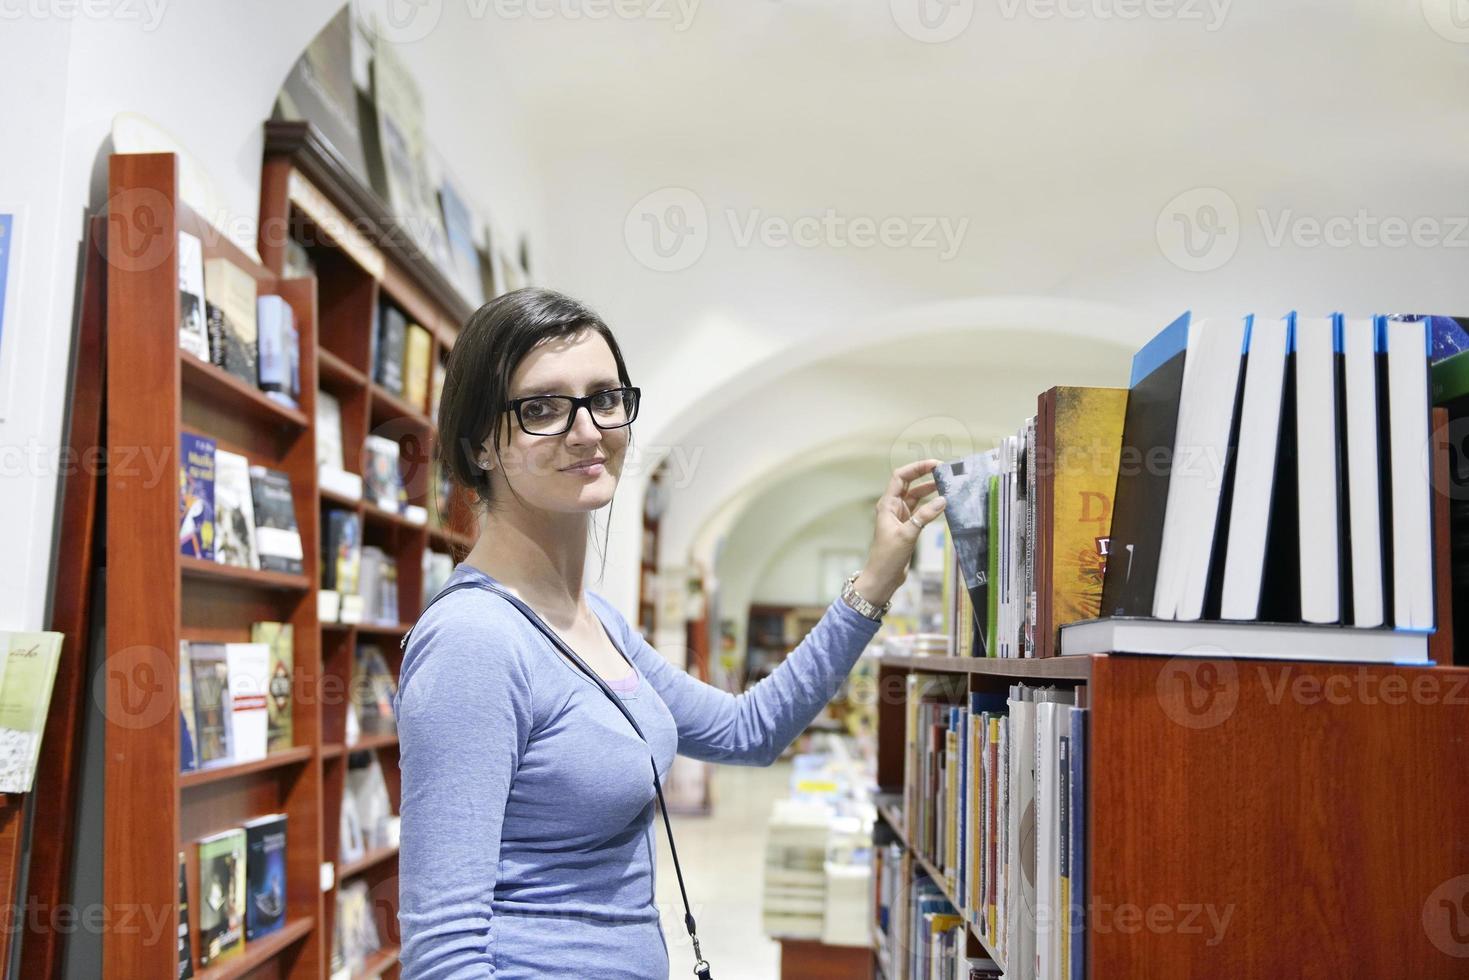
left=483, top=329, right=632, bottom=513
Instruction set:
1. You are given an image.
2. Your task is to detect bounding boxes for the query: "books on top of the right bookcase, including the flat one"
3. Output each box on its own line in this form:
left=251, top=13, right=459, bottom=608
left=934, top=314, right=1444, bottom=663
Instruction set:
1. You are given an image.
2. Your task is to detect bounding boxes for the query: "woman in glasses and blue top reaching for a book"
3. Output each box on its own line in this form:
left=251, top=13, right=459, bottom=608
left=397, top=289, right=943, bottom=980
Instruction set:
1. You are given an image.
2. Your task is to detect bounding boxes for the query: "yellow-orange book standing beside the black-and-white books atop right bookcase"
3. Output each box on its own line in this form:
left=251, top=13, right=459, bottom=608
left=1050, top=388, right=1127, bottom=629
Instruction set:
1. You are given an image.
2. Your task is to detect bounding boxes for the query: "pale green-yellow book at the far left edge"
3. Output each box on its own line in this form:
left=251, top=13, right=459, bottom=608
left=0, top=632, right=63, bottom=793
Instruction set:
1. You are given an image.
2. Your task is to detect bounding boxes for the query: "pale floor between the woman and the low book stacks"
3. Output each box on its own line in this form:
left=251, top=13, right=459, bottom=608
left=655, top=763, right=790, bottom=980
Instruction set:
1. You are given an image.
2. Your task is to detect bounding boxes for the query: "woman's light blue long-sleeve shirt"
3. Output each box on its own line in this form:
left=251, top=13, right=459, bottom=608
left=395, top=564, right=878, bottom=980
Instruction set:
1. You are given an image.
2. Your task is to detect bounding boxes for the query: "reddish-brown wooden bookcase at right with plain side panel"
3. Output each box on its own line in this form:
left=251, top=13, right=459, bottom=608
left=873, top=652, right=1469, bottom=980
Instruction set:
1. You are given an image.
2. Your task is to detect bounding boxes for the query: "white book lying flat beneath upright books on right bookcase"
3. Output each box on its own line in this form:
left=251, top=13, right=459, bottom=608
left=1061, top=616, right=1429, bottom=664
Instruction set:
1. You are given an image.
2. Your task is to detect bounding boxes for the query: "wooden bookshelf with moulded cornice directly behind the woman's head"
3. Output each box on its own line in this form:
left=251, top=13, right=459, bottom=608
left=259, top=122, right=477, bottom=979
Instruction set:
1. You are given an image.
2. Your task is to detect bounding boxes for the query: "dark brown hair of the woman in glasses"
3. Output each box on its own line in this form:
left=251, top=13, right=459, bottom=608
left=436, top=287, right=632, bottom=543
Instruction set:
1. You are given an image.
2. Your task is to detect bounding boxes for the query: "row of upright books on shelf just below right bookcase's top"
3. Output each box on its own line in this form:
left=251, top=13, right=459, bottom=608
left=903, top=673, right=1087, bottom=980
